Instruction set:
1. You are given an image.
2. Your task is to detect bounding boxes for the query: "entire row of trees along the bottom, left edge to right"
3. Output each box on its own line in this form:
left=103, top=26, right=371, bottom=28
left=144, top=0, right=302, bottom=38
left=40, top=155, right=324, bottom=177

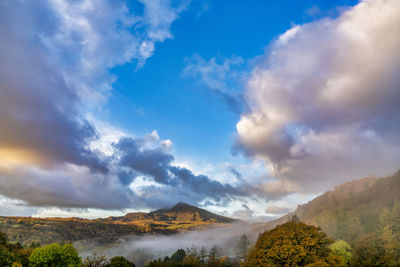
left=0, top=216, right=400, bottom=267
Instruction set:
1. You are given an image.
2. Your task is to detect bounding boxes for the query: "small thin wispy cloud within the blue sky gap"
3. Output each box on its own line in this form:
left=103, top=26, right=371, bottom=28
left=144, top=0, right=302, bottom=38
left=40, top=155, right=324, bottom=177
left=183, top=54, right=245, bottom=113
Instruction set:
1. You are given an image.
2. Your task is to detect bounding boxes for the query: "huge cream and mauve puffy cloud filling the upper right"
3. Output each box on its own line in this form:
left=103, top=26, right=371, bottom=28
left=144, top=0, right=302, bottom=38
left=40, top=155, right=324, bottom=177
left=237, top=0, right=400, bottom=194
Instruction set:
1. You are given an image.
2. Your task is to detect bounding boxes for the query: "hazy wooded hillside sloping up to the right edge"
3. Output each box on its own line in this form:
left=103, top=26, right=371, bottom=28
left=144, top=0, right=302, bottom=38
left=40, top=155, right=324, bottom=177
left=256, top=171, right=400, bottom=243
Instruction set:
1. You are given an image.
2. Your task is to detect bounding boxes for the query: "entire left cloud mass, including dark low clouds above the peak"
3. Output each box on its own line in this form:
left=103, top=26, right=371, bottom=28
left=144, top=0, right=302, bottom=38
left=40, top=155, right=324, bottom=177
left=0, top=0, right=250, bottom=213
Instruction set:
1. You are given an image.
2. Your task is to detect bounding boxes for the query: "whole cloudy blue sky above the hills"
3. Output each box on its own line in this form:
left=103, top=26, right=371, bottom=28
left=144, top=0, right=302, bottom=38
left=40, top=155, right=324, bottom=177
left=0, top=0, right=400, bottom=220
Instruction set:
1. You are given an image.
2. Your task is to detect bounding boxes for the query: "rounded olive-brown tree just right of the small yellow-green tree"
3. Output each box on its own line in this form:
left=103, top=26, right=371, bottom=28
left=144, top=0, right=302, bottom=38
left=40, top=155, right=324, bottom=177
left=351, top=233, right=385, bottom=267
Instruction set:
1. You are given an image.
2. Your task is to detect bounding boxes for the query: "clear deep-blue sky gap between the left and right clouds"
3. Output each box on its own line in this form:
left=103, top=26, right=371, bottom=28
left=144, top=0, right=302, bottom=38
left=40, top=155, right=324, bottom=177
left=107, top=1, right=357, bottom=161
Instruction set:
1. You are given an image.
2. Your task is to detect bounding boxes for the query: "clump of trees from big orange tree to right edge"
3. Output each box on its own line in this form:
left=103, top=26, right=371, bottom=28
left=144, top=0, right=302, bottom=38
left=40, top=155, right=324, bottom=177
left=244, top=216, right=400, bottom=267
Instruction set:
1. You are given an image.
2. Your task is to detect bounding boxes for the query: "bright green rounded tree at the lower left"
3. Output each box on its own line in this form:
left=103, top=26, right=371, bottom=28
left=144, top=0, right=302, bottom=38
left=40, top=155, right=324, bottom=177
left=29, top=243, right=81, bottom=267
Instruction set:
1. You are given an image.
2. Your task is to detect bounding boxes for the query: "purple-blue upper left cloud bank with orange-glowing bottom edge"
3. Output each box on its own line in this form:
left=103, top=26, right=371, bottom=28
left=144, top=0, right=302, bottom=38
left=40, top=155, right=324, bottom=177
left=0, top=0, right=187, bottom=172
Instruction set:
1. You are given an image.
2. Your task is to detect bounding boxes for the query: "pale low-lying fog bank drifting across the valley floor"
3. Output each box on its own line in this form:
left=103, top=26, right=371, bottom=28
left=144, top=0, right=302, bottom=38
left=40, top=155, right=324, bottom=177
left=74, top=223, right=264, bottom=266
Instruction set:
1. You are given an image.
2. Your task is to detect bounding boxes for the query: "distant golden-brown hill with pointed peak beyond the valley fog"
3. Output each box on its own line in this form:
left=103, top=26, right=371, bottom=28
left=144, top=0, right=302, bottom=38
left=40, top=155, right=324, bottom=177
left=0, top=202, right=236, bottom=245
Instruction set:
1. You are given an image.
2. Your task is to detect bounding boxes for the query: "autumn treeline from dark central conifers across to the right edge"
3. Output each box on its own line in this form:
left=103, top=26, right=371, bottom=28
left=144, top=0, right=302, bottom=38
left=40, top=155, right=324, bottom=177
left=147, top=216, right=400, bottom=267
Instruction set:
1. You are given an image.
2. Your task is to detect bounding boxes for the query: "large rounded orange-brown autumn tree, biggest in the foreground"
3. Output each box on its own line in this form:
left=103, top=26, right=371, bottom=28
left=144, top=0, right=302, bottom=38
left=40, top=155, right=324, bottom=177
left=245, top=221, right=340, bottom=266
